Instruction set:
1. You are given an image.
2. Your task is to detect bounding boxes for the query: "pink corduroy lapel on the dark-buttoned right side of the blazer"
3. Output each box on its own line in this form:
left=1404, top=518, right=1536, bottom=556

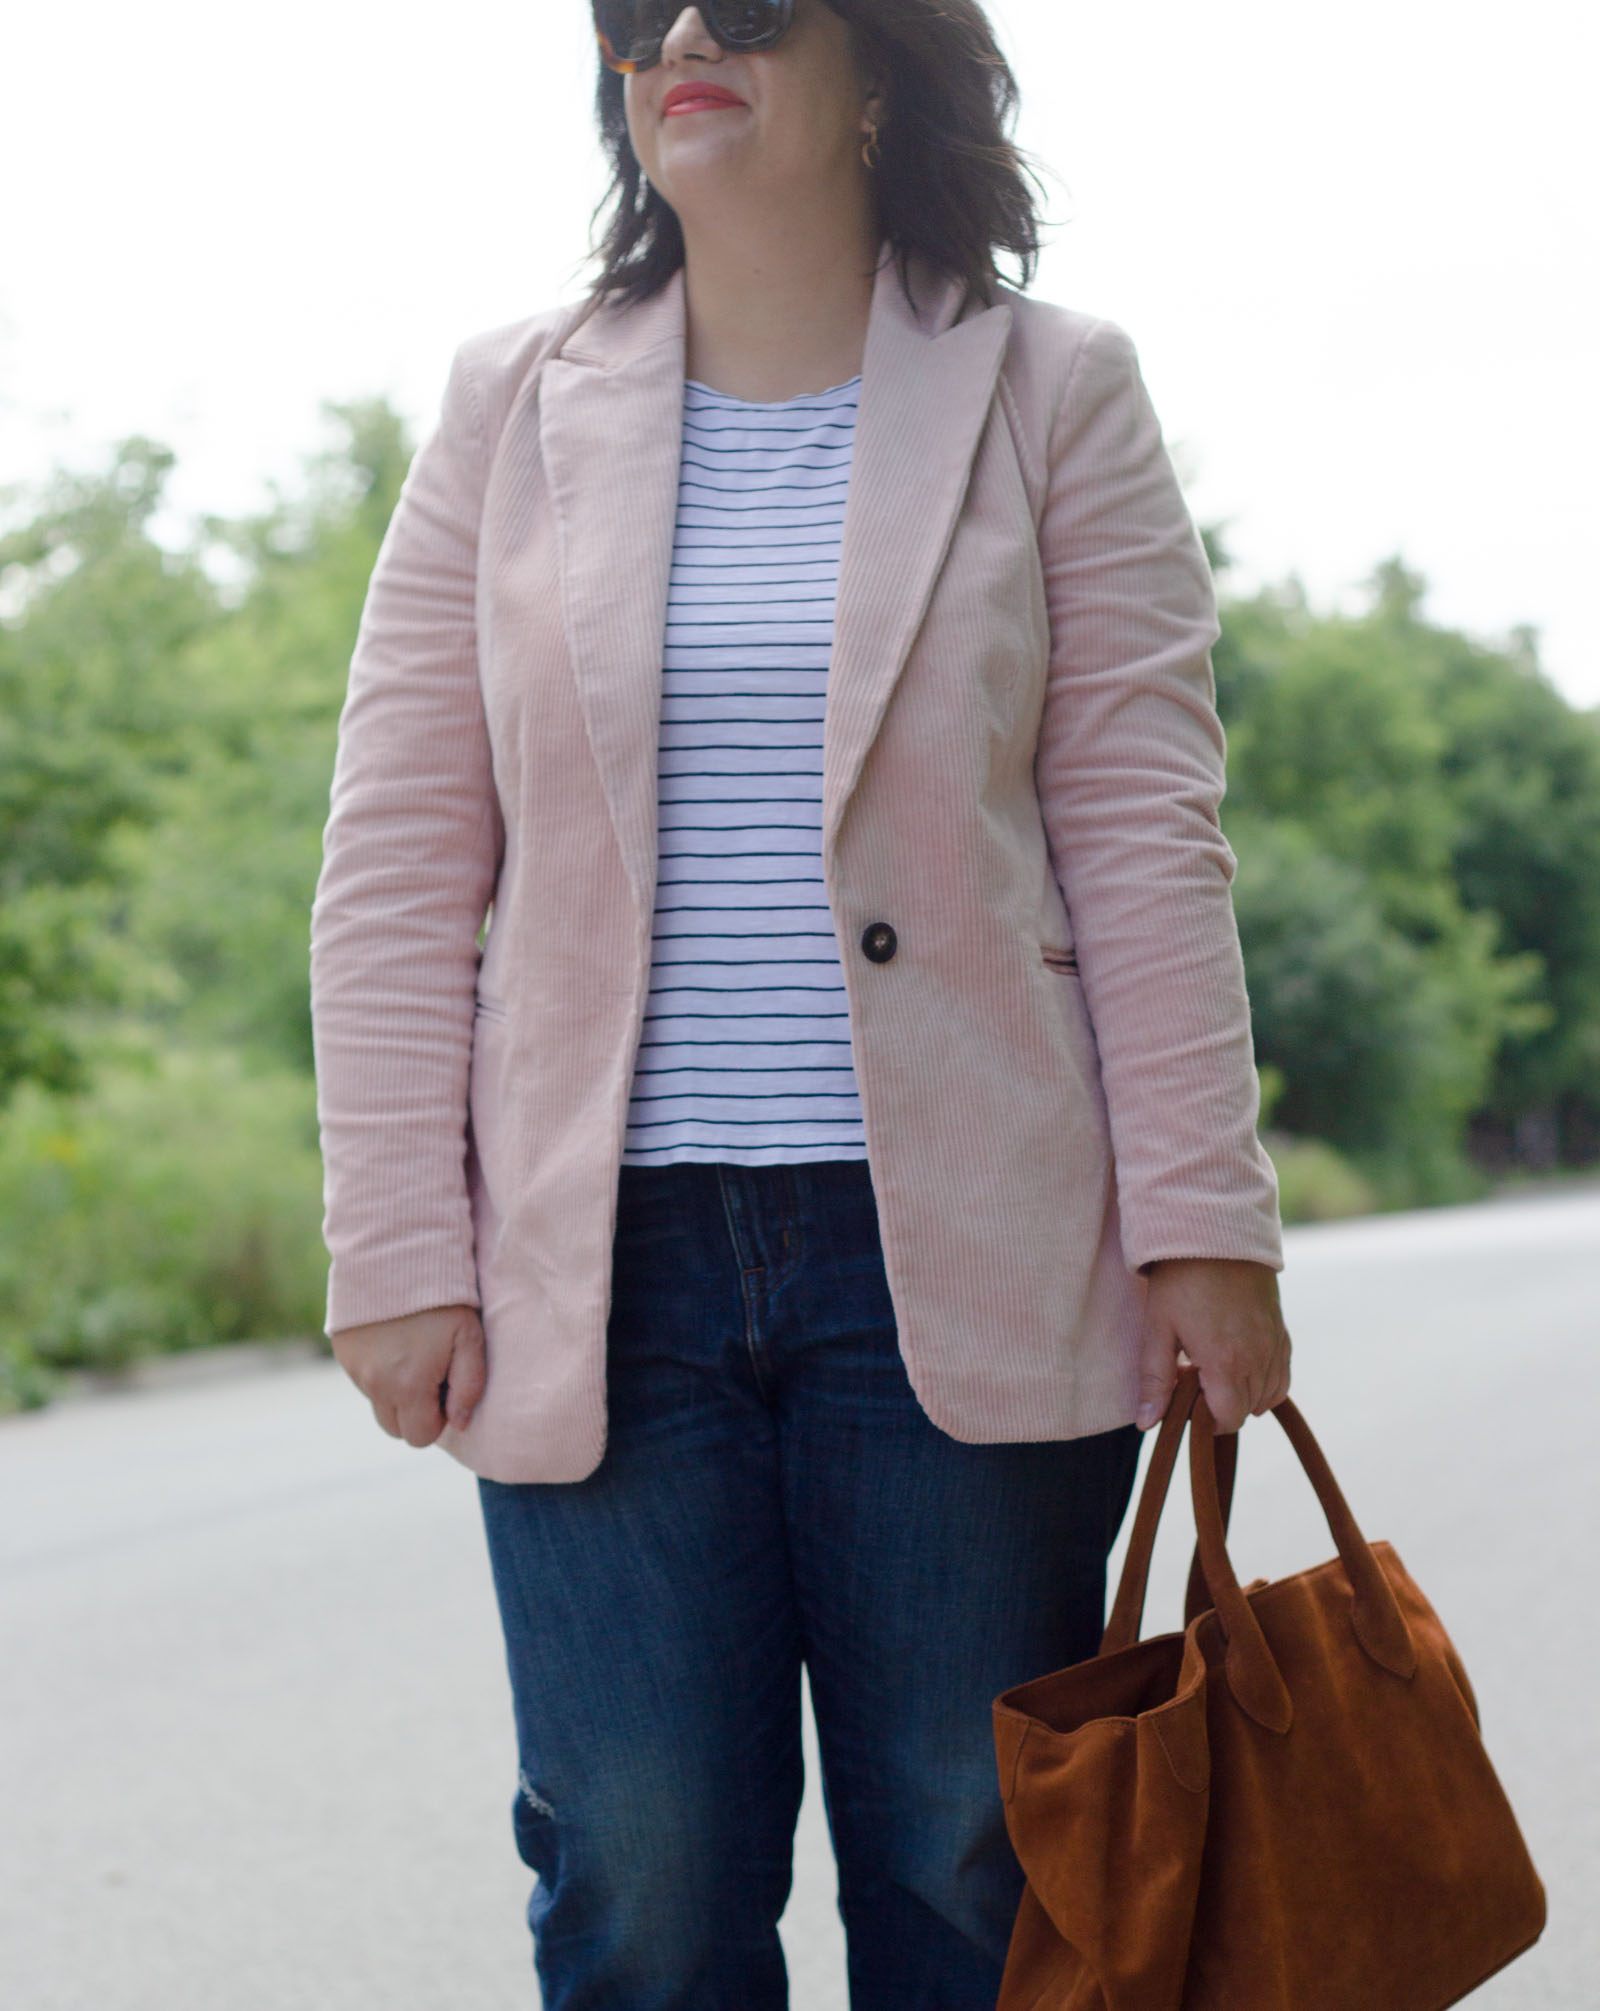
left=822, top=255, right=1011, bottom=853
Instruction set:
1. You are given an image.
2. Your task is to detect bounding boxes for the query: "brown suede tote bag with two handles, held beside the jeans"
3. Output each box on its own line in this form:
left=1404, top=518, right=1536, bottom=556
left=995, top=1369, right=1544, bottom=2011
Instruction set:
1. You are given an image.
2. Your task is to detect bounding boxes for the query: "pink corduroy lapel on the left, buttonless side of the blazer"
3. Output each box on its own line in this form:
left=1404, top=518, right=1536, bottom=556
left=539, top=276, right=683, bottom=923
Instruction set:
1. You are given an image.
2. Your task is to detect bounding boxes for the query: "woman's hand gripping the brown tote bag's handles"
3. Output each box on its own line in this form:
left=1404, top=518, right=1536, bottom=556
left=1138, top=1257, right=1290, bottom=1432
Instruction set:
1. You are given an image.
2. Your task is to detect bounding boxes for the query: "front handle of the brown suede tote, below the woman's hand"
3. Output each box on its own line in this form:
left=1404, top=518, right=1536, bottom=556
left=1174, top=1396, right=1417, bottom=1731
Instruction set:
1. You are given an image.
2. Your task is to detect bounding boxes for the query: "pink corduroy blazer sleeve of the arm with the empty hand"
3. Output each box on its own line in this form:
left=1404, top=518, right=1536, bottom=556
left=312, top=356, right=503, bottom=1333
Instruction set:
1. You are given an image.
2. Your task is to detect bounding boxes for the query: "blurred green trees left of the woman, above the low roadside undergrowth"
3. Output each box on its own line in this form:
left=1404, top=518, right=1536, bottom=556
left=0, top=404, right=410, bottom=1102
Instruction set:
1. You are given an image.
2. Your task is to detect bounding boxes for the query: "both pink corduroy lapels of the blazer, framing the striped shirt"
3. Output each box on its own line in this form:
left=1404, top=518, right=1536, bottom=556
left=539, top=251, right=1011, bottom=931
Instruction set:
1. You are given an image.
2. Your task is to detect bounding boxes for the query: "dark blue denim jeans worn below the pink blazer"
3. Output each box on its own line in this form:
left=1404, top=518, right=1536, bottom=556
left=480, top=1160, right=1138, bottom=2011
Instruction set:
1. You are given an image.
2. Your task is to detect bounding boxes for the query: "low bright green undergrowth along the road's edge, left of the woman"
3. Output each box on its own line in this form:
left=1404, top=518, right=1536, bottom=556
left=0, top=1052, right=328, bottom=1410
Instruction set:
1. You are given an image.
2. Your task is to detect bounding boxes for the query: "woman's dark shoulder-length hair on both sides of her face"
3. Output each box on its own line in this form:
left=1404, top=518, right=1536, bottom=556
left=595, top=0, right=1039, bottom=304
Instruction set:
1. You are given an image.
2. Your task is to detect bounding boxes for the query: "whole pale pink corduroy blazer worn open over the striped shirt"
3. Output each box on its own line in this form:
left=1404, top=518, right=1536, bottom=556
left=312, top=261, right=1280, bottom=1480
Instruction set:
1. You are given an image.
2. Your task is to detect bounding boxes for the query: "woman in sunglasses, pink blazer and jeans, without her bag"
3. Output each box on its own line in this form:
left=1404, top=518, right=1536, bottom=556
left=314, top=0, right=1288, bottom=2011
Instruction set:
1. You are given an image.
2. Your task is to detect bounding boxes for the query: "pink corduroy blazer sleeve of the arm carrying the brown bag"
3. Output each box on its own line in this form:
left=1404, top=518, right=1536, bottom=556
left=1035, top=322, right=1282, bottom=1269
